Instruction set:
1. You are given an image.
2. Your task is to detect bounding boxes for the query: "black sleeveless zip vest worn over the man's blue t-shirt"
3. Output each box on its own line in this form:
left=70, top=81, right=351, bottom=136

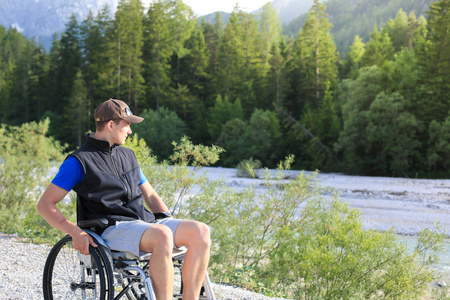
left=70, top=135, right=155, bottom=225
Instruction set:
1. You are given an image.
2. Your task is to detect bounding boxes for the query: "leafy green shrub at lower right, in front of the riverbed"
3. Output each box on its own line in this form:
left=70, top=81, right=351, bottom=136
left=265, top=198, right=433, bottom=299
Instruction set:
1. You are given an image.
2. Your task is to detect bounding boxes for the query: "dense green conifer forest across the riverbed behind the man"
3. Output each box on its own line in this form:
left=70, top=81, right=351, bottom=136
left=0, top=0, right=450, bottom=177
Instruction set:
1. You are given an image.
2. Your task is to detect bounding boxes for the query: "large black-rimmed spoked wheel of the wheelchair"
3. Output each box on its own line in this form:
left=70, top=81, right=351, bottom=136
left=43, top=235, right=110, bottom=300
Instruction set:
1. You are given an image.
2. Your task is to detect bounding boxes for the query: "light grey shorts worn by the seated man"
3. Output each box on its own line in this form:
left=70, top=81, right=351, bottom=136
left=102, top=218, right=182, bottom=256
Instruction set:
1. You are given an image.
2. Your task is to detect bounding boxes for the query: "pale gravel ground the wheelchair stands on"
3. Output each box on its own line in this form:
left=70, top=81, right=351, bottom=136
left=0, top=233, right=279, bottom=300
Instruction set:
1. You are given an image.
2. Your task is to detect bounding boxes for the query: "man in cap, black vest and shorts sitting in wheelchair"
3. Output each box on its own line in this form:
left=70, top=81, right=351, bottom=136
left=38, top=99, right=211, bottom=300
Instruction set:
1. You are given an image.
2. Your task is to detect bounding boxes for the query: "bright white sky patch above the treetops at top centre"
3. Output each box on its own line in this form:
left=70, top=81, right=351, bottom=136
left=143, top=0, right=270, bottom=16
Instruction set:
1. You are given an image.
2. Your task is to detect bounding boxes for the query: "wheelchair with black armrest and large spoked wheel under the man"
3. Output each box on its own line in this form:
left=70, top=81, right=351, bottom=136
left=43, top=219, right=216, bottom=300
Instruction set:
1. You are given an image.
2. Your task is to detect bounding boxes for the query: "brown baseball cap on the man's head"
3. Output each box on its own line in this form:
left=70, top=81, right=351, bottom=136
left=94, top=99, right=144, bottom=123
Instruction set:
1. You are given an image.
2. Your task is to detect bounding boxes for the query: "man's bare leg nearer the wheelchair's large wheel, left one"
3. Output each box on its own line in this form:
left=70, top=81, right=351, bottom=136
left=139, top=224, right=174, bottom=300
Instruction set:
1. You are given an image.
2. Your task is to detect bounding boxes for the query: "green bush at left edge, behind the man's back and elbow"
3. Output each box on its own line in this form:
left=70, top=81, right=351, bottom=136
left=0, top=119, right=68, bottom=243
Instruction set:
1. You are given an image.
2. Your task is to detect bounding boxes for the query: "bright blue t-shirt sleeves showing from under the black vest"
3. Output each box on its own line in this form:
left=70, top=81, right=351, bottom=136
left=52, top=156, right=147, bottom=191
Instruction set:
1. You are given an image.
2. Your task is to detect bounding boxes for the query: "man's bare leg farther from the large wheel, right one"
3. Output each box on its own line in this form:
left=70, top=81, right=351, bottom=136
left=175, top=220, right=211, bottom=300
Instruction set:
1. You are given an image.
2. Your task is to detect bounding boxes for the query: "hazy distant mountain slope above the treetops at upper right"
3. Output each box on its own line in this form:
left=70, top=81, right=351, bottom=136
left=283, top=0, right=433, bottom=55
